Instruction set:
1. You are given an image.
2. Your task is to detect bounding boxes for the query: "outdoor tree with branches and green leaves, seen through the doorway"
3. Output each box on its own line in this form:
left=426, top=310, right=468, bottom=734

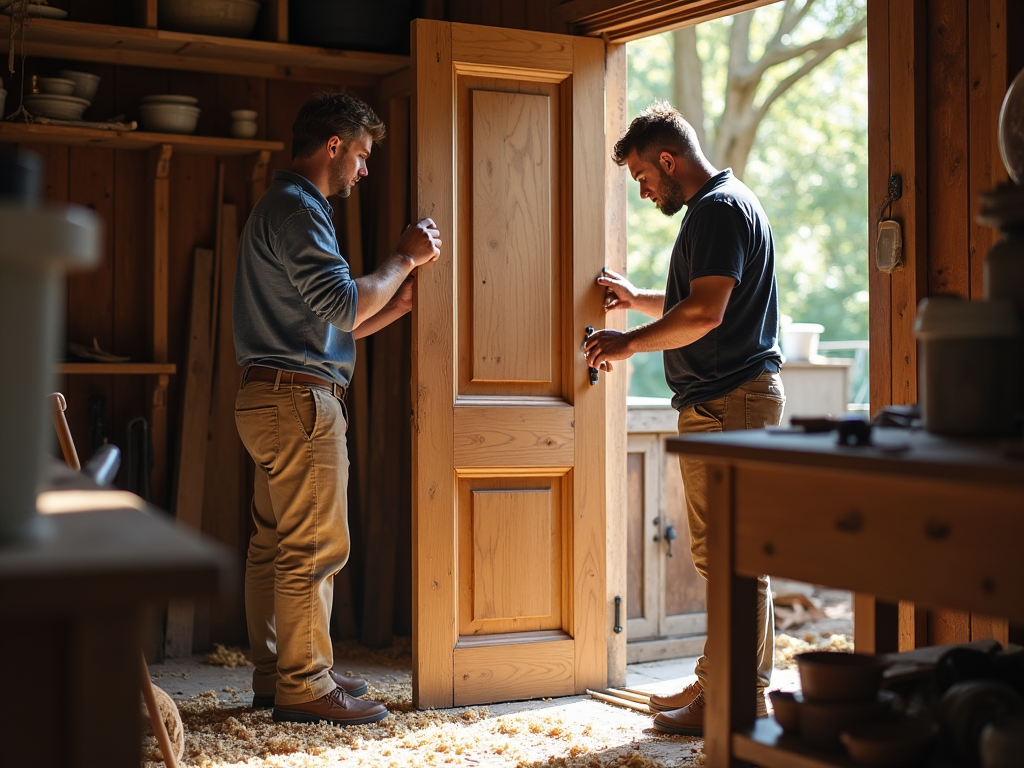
left=628, top=0, right=867, bottom=395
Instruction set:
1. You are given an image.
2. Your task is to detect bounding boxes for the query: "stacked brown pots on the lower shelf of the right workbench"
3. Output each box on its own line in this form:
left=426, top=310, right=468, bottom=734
left=796, top=651, right=894, bottom=752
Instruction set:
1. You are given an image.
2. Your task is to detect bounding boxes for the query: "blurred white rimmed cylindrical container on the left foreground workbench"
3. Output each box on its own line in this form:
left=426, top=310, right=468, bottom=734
left=0, top=202, right=101, bottom=540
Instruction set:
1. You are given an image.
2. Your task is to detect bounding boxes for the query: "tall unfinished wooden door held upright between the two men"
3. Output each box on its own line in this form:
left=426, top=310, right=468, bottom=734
left=413, top=20, right=610, bottom=709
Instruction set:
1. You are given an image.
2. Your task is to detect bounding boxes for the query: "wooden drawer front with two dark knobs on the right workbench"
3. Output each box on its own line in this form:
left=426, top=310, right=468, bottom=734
left=732, top=465, right=1024, bottom=622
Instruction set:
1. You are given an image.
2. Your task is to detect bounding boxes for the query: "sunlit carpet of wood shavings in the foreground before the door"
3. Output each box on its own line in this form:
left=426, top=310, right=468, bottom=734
left=143, top=660, right=703, bottom=768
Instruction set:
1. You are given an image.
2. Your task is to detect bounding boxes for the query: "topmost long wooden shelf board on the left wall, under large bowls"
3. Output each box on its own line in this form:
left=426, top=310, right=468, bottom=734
left=0, top=15, right=410, bottom=85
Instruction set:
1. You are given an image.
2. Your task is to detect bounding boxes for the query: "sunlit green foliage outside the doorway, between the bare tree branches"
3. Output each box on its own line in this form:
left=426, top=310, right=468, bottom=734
left=627, top=0, right=868, bottom=396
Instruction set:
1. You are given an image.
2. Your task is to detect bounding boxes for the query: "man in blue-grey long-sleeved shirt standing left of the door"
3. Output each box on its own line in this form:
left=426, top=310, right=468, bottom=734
left=232, top=93, right=440, bottom=725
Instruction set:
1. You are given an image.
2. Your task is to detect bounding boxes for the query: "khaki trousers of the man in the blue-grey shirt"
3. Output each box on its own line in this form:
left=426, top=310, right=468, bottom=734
left=234, top=382, right=349, bottom=705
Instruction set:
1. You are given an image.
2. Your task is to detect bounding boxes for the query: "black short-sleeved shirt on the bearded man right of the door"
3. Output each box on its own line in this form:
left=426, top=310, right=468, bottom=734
left=665, top=168, right=782, bottom=411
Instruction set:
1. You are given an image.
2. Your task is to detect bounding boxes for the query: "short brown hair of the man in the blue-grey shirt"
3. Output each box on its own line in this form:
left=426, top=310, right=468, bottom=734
left=292, top=91, right=386, bottom=160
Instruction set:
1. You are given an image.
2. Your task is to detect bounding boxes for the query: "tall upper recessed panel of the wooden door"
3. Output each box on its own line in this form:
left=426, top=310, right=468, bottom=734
left=454, top=72, right=571, bottom=398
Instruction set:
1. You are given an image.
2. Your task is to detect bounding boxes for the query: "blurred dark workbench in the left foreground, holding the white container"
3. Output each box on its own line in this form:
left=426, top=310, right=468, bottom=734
left=0, top=468, right=231, bottom=768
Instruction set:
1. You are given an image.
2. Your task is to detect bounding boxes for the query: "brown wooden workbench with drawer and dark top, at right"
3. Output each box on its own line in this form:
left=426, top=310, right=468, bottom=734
left=667, top=427, right=1024, bottom=768
